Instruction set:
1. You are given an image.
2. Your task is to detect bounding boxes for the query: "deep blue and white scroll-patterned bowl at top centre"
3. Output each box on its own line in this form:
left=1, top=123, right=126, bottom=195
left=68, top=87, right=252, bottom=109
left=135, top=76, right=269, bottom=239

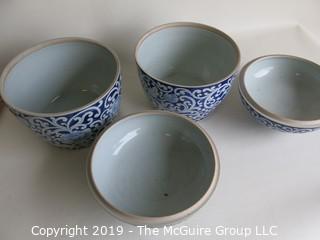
left=135, top=23, right=240, bottom=120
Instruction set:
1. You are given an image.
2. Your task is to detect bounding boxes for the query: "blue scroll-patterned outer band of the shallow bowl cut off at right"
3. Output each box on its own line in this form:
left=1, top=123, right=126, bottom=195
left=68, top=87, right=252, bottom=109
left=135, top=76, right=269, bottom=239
left=240, top=93, right=318, bottom=133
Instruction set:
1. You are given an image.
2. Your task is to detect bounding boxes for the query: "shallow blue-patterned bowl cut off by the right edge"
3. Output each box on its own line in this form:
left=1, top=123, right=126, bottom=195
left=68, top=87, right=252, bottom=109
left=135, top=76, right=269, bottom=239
left=239, top=55, right=320, bottom=133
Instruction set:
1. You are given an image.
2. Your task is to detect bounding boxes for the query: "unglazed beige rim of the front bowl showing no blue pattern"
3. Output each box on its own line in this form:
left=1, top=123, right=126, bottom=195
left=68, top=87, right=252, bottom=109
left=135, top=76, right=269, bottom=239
left=86, top=110, right=220, bottom=225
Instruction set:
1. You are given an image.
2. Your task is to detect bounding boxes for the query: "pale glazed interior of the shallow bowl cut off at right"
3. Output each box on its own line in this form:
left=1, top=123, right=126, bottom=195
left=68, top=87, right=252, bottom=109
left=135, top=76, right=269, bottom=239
left=244, top=56, right=320, bottom=121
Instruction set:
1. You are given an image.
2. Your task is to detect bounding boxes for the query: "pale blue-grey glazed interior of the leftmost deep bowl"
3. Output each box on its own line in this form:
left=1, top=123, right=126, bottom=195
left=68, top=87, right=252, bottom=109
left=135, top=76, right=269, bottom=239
left=2, top=40, right=117, bottom=113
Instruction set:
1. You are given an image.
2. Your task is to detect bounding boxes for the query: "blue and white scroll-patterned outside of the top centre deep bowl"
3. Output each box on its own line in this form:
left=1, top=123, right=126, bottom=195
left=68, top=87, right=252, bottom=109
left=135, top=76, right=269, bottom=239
left=139, top=69, right=235, bottom=121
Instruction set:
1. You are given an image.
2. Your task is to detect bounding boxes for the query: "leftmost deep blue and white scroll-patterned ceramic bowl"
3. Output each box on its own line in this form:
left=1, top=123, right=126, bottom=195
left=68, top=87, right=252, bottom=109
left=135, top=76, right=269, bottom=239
left=1, top=38, right=121, bottom=149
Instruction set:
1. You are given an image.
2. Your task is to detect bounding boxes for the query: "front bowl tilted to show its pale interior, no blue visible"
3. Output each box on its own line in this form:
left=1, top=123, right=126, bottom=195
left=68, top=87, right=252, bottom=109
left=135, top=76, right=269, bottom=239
left=87, top=111, right=219, bottom=227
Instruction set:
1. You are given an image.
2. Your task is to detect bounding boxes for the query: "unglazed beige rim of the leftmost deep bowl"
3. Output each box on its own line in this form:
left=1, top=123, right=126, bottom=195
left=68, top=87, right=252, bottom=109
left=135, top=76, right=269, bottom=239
left=0, top=37, right=120, bottom=117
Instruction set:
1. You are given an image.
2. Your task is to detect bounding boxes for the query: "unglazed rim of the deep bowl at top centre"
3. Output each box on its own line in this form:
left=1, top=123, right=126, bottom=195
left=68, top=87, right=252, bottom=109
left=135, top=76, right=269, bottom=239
left=134, top=22, right=241, bottom=88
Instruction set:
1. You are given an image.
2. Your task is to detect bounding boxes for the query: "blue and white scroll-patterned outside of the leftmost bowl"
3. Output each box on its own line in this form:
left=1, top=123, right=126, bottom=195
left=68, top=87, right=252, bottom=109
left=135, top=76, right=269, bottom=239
left=10, top=76, right=121, bottom=149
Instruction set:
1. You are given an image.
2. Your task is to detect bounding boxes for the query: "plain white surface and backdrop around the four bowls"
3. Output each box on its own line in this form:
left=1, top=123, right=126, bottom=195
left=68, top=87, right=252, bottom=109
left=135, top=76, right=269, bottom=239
left=0, top=0, right=320, bottom=240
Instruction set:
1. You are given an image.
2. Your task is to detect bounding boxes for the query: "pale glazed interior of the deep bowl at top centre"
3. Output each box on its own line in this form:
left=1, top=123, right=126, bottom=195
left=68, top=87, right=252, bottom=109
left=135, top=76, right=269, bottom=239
left=136, top=24, right=239, bottom=86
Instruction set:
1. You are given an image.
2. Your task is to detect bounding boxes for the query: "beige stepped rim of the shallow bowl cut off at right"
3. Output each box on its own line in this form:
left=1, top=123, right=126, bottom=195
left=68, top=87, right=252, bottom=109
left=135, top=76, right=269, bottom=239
left=238, top=54, right=320, bottom=128
